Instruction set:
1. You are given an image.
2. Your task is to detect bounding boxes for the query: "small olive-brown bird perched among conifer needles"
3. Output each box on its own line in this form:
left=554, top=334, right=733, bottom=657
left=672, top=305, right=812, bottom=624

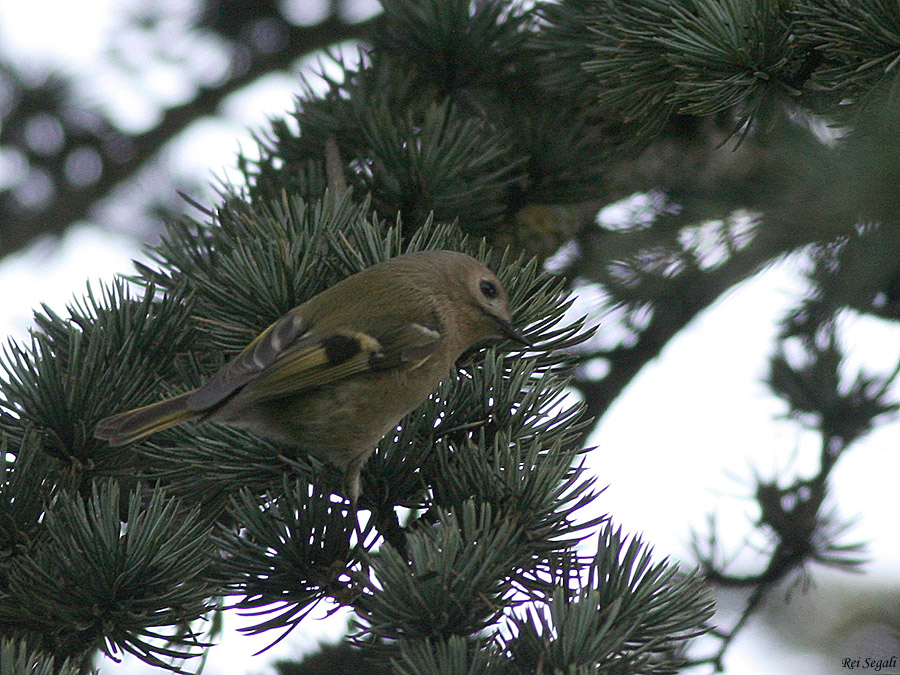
left=94, top=251, right=531, bottom=507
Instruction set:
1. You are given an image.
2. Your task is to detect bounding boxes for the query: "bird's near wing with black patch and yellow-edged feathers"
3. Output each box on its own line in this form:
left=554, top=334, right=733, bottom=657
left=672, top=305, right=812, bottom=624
left=197, top=323, right=442, bottom=405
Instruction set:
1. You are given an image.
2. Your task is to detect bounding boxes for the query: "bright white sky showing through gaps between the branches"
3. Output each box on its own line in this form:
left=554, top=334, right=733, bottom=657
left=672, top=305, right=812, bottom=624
left=0, top=0, right=900, bottom=675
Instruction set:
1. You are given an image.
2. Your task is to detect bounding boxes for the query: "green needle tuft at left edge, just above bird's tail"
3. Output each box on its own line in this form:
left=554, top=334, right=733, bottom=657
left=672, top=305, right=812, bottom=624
left=0, top=282, right=192, bottom=471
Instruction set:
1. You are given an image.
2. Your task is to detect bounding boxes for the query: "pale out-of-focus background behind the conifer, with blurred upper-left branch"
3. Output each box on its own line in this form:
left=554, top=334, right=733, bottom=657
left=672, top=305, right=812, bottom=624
left=0, top=0, right=900, bottom=675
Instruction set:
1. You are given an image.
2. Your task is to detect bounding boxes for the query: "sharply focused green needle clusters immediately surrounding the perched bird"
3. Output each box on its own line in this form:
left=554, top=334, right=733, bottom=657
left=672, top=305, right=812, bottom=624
left=0, top=177, right=716, bottom=665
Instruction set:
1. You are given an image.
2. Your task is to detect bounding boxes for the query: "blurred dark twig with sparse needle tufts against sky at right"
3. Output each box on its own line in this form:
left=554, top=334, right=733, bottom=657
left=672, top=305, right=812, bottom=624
left=694, top=228, right=900, bottom=670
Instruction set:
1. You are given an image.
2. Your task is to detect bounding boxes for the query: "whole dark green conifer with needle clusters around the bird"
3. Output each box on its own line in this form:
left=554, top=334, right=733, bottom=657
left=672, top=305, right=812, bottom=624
left=0, top=0, right=900, bottom=675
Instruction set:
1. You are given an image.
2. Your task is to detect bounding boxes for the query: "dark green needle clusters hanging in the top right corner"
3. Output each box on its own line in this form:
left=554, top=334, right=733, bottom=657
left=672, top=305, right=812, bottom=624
left=538, top=0, right=900, bottom=142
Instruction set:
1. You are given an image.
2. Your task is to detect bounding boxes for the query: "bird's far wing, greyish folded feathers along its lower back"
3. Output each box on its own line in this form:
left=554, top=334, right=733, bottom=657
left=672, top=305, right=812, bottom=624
left=187, top=313, right=311, bottom=412
